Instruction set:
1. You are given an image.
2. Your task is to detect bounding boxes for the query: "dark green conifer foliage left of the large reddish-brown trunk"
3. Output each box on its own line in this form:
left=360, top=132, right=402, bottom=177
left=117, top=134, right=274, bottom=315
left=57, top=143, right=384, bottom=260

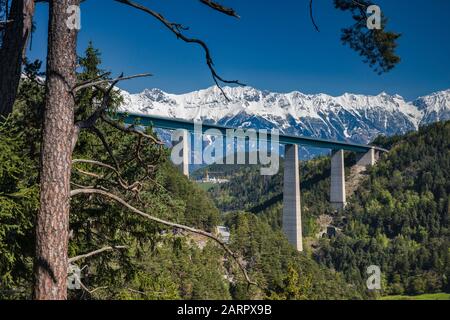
left=0, top=118, right=38, bottom=298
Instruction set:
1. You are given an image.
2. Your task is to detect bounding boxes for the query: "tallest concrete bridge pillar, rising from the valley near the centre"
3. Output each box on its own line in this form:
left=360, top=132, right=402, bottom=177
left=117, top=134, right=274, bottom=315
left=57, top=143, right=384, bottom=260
left=283, top=144, right=303, bottom=251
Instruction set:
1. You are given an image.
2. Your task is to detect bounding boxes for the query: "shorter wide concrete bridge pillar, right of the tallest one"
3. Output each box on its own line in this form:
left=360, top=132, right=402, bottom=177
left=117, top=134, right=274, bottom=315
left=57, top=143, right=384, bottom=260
left=330, top=150, right=346, bottom=210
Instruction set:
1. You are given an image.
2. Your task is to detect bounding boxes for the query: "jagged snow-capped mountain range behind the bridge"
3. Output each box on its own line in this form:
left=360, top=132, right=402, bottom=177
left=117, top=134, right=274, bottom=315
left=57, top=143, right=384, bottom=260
left=121, top=86, right=450, bottom=143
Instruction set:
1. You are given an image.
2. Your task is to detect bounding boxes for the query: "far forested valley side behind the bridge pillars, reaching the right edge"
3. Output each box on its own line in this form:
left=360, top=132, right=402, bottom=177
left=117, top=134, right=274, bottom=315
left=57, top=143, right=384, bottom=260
left=209, top=122, right=450, bottom=295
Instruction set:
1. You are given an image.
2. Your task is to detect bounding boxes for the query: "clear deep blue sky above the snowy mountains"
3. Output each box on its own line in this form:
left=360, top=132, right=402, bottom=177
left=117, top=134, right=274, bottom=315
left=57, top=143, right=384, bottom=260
left=29, top=0, right=450, bottom=99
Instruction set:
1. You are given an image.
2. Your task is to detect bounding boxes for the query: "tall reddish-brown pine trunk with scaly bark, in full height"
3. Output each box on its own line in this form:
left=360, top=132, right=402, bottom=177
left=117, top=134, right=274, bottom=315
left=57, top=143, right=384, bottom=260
left=34, top=0, right=79, bottom=299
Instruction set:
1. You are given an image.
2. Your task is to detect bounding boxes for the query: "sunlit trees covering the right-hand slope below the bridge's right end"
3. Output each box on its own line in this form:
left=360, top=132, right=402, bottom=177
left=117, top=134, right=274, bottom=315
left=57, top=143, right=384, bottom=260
left=317, top=122, right=450, bottom=294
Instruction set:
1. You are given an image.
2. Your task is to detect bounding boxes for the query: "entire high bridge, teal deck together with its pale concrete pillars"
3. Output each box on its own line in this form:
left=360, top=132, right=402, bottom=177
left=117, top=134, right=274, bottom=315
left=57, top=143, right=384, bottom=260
left=119, top=114, right=387, bottom=251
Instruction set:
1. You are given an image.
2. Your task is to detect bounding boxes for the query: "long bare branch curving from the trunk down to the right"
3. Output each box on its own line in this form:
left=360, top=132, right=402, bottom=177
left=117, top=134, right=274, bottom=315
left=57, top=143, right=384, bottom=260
left=70, top=189, right=257, bottom=285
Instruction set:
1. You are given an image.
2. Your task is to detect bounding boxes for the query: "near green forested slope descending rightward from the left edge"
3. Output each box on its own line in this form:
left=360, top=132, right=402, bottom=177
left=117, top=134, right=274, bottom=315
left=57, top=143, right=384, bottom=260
left=0, top=46, right=363, bottom=299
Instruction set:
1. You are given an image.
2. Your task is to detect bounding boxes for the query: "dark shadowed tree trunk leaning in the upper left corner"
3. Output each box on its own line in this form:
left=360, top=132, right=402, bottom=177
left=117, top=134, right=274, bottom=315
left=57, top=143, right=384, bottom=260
left=0, top=0, right=34, bottom=117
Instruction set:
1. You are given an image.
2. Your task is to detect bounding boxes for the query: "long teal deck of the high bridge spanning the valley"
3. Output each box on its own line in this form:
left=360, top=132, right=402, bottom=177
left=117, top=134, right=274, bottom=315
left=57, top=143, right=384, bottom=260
left=119, top=113, right=387, bottom=153
